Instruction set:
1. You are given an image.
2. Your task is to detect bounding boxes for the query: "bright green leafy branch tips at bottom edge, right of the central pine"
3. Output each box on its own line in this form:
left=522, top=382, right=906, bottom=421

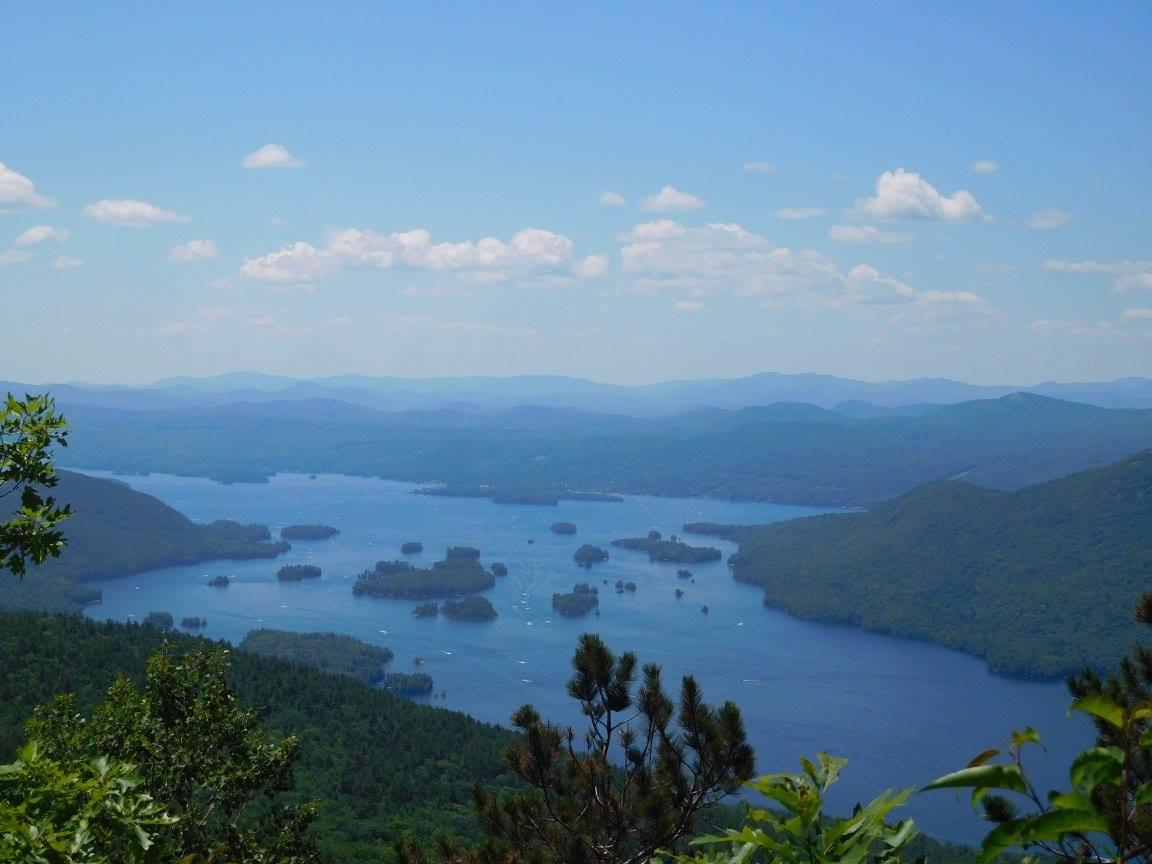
left=677, top=753, right=916, bottom=864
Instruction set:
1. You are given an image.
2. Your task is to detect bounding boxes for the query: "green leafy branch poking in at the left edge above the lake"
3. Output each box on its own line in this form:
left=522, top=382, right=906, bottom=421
left=0, top=393, right=71, bottom=576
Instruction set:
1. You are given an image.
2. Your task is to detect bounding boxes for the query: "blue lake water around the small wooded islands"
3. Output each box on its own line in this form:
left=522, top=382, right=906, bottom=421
left=81, top=472, right=1090, bottom=842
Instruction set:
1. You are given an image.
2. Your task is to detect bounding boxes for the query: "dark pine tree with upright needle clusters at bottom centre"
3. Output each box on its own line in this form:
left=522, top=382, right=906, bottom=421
left=407, top=634, right=753, bottom=864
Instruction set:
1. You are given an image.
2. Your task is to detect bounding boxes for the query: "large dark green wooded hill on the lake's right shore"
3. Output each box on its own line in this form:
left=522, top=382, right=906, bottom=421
left=732, top=450, right=1152, bottom=676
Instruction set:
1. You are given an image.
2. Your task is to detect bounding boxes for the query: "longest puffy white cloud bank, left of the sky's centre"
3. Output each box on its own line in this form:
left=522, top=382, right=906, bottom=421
left=240, top=228, right=573, bottom=283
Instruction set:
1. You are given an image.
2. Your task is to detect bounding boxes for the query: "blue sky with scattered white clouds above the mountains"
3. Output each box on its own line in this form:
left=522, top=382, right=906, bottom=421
left=0, top=2, right=1152, bottom=384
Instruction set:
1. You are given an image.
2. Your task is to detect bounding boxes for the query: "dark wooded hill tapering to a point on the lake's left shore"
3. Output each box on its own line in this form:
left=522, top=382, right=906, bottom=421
left=0, top=471, right=288, bottom=611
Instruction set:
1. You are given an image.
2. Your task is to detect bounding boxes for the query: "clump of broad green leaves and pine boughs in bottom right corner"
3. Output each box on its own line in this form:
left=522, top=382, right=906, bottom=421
left=925, top=593, right=1152, bottom=864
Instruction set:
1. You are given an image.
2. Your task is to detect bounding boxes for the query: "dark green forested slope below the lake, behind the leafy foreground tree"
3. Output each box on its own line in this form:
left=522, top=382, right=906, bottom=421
left=0, top=612, right=511, bottom=864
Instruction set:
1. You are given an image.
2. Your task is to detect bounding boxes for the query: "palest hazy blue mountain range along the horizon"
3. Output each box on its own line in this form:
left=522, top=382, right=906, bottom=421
left=11, top=372, right=1152, bottom=417
